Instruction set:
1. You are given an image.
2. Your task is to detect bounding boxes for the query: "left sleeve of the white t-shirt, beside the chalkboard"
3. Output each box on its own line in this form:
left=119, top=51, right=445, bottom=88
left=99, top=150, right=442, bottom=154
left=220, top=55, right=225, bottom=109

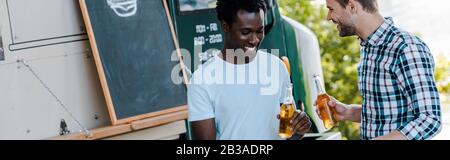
left=188, top=84, right=215, bottom=122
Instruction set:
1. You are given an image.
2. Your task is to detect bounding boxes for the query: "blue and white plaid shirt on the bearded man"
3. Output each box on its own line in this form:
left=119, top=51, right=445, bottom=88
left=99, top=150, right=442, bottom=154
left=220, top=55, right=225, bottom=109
left=358, top=18, right=441, bottom=140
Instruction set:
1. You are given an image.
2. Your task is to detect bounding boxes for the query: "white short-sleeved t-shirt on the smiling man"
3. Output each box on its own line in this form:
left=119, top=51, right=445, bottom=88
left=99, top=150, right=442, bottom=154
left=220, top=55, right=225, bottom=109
left=188, top=51, right=290, bottom=140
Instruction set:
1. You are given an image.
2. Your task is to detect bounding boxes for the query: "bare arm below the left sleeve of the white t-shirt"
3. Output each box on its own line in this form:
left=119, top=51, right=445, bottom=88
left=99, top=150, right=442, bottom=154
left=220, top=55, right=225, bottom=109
left=191, top=118, right=216, bottom=140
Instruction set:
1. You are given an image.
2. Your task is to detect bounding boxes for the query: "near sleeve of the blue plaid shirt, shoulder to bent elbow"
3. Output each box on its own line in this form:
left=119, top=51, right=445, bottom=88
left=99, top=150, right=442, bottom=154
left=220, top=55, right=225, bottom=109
left=392, top=44, right=441, bottom=140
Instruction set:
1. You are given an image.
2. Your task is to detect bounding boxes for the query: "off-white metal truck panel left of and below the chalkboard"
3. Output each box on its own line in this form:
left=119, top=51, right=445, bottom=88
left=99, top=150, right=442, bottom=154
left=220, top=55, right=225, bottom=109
left=0, top=0, right=185, bottom=139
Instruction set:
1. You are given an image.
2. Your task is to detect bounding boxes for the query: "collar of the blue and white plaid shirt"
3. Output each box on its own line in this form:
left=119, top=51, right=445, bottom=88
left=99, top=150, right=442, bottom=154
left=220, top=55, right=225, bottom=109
left=359, top=17, right=394, bottom=46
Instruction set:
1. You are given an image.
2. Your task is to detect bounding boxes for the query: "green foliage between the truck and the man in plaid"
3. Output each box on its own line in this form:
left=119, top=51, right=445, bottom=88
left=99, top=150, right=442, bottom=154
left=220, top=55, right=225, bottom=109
left=278, top=0, right=361, bottom=140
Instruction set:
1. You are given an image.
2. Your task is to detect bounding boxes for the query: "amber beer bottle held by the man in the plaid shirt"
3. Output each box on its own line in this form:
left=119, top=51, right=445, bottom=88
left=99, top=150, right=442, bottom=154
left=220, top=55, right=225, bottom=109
left=314, top=75, right=337, bottom=129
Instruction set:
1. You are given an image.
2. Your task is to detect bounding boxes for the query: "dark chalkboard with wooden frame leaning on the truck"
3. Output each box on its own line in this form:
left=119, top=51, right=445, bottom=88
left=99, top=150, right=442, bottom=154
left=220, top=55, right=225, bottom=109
left=80, top=0, right=187, bottom=124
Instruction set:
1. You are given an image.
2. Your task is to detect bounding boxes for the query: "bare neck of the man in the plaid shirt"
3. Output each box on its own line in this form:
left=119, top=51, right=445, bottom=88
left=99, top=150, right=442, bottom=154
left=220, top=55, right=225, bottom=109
left=356, top=12, right=385, bottom=41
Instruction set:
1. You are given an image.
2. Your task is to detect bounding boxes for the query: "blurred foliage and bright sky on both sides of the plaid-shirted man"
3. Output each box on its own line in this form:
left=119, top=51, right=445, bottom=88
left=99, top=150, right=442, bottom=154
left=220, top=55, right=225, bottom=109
left=278, top=0, right=450, bottom=140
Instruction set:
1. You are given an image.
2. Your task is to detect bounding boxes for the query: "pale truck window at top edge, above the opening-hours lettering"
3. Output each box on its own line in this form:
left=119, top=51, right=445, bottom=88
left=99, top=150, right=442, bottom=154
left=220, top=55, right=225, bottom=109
left=178, top=0, right=217, bottom=12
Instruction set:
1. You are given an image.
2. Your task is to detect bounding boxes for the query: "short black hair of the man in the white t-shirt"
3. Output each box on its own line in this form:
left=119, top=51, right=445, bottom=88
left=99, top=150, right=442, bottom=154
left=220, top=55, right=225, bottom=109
left=216, top=0, right=267, bottom=26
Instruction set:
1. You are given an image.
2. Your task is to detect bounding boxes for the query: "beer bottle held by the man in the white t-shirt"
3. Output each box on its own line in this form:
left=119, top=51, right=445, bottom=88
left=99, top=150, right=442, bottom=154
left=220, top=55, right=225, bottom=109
left=278, top=84, right=295, bottom=138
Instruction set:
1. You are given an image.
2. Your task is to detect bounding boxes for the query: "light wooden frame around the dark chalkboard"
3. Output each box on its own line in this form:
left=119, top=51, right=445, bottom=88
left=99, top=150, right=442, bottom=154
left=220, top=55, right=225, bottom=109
left=79, top=0, right=188, bottom=125
